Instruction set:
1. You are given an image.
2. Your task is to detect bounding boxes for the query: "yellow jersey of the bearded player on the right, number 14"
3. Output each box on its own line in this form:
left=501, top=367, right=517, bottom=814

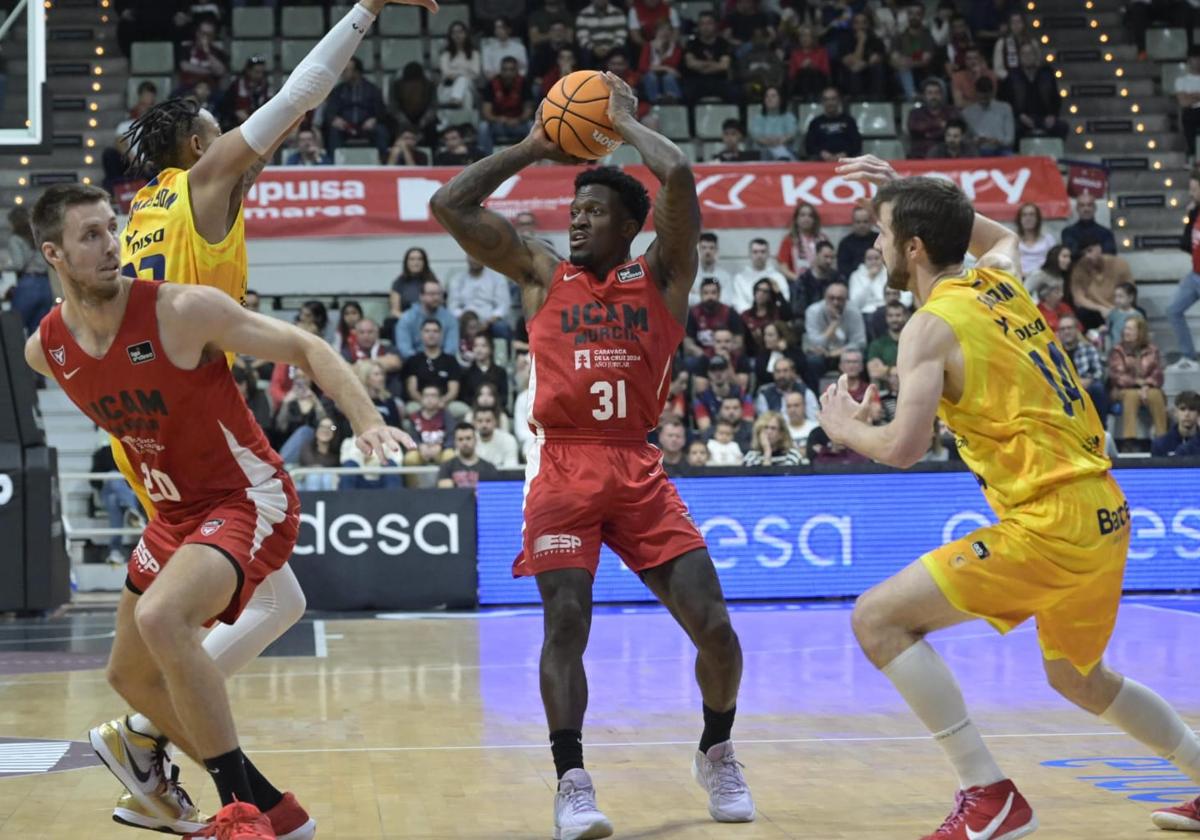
left=922, top=269, right=1112, bottom=517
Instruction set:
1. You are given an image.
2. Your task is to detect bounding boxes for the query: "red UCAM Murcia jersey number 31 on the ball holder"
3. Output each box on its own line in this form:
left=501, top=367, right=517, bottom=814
left=528, top=257, right=684, bottom=443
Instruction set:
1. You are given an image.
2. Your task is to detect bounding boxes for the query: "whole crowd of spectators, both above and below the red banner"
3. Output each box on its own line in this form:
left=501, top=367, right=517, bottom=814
left=49, top=0, right=1200, bottom=488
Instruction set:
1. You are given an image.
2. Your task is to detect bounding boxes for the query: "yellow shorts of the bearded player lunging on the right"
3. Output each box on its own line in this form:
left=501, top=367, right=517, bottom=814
left=920, top=475, right=1129, bottom=674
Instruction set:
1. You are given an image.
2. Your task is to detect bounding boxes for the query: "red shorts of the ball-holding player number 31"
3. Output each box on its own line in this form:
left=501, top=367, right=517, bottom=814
left=512, top=440, right=704, bottom=577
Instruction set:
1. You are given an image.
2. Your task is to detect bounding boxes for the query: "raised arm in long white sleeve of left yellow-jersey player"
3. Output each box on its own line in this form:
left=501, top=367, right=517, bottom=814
left=188, top=0, right=438, bottom=242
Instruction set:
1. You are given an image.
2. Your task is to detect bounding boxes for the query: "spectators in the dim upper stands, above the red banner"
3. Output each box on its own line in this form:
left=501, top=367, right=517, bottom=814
left=113, top=0, right=1068, bottom=166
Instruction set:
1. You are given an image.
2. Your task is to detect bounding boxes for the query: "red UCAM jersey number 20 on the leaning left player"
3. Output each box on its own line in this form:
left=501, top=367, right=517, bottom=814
left=40, top=281, right=290, bottom=524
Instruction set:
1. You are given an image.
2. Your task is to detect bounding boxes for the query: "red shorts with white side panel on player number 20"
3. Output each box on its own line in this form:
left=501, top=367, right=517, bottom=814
left=127, top=473, right=300, bottom=624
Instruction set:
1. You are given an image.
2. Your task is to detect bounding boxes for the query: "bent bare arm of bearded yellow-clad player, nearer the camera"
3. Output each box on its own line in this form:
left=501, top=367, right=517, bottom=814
left=817, top=311, right=958, bottom=468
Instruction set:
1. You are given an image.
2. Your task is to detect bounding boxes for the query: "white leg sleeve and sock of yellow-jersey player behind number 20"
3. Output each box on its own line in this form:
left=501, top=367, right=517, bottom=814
left=130, top=565, right=306, bottom=755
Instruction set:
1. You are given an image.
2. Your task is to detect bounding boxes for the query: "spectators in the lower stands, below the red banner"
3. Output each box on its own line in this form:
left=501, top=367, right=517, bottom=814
left=196, top=188, right=1200, bottom=488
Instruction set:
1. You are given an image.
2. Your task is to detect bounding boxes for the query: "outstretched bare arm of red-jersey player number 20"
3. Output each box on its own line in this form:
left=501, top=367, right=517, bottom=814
left=158, top=286, right=415, bottom=457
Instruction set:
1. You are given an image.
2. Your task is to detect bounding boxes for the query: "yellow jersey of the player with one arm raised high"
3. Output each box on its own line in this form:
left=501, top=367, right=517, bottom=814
left=121, top=168, right=247, bottom=304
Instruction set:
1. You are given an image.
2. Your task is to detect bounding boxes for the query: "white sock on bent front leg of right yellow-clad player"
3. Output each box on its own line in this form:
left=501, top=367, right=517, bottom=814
left=883, top=640, right=1006, bottom=787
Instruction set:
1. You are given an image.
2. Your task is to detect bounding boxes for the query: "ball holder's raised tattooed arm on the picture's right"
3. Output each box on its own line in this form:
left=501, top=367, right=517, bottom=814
left=602, top=73, right=700, bottom=295
